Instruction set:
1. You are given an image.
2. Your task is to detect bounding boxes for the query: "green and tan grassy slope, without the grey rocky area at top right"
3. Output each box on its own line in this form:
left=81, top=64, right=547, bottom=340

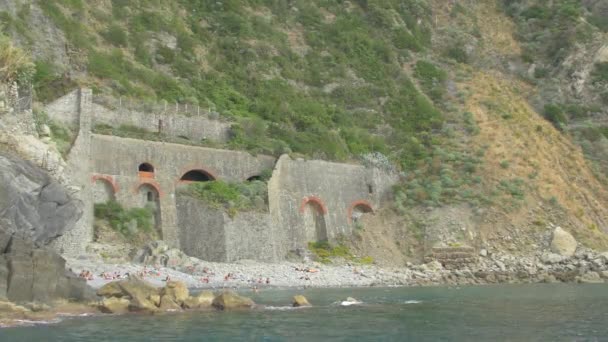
left=1, top=0, right=608, bottom=256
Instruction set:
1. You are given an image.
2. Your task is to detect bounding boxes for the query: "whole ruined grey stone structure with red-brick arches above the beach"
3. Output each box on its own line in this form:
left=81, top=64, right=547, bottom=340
left=46, top=89, right=396, bottom=261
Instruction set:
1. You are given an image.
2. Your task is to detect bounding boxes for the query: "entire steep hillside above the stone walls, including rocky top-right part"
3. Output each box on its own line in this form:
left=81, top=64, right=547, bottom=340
left=0, top=0, right=608, bottom=258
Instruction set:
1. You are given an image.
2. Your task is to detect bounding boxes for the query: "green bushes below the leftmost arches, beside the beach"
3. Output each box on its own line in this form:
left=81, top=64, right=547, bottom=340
left=95, top=201, right=154, bottom=236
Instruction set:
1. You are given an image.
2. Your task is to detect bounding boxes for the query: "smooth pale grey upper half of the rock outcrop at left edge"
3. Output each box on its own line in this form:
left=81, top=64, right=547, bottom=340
left=0, top=152, right=82, bottom=246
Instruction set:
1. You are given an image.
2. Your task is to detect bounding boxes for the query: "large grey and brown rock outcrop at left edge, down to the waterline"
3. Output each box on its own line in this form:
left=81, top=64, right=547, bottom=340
left=0, top=152, right=92, bottom=302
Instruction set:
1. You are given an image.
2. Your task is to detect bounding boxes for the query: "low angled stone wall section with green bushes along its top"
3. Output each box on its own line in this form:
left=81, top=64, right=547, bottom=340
left=176, top=195, right=280, bottom=262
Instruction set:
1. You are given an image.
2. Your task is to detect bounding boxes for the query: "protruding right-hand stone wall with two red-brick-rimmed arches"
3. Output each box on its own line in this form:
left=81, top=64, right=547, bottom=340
left=269, top=155, right=396, bottom=257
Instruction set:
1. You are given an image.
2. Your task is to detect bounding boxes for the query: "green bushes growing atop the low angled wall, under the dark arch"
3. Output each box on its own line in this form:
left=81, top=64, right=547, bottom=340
left=186, top=180, right=268, bottom=216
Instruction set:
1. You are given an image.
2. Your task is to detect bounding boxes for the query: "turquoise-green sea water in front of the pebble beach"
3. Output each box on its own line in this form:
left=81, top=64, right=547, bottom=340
left=0, top=284, right=608, bottom=342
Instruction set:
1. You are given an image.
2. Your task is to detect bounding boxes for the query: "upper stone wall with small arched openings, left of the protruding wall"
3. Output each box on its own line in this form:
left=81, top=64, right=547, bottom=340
left=87, top=134, right=275, bottom=247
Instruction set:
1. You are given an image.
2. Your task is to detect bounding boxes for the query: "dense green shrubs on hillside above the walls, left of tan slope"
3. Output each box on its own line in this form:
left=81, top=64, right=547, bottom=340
left=24, top=0, right=447, bottom=169
